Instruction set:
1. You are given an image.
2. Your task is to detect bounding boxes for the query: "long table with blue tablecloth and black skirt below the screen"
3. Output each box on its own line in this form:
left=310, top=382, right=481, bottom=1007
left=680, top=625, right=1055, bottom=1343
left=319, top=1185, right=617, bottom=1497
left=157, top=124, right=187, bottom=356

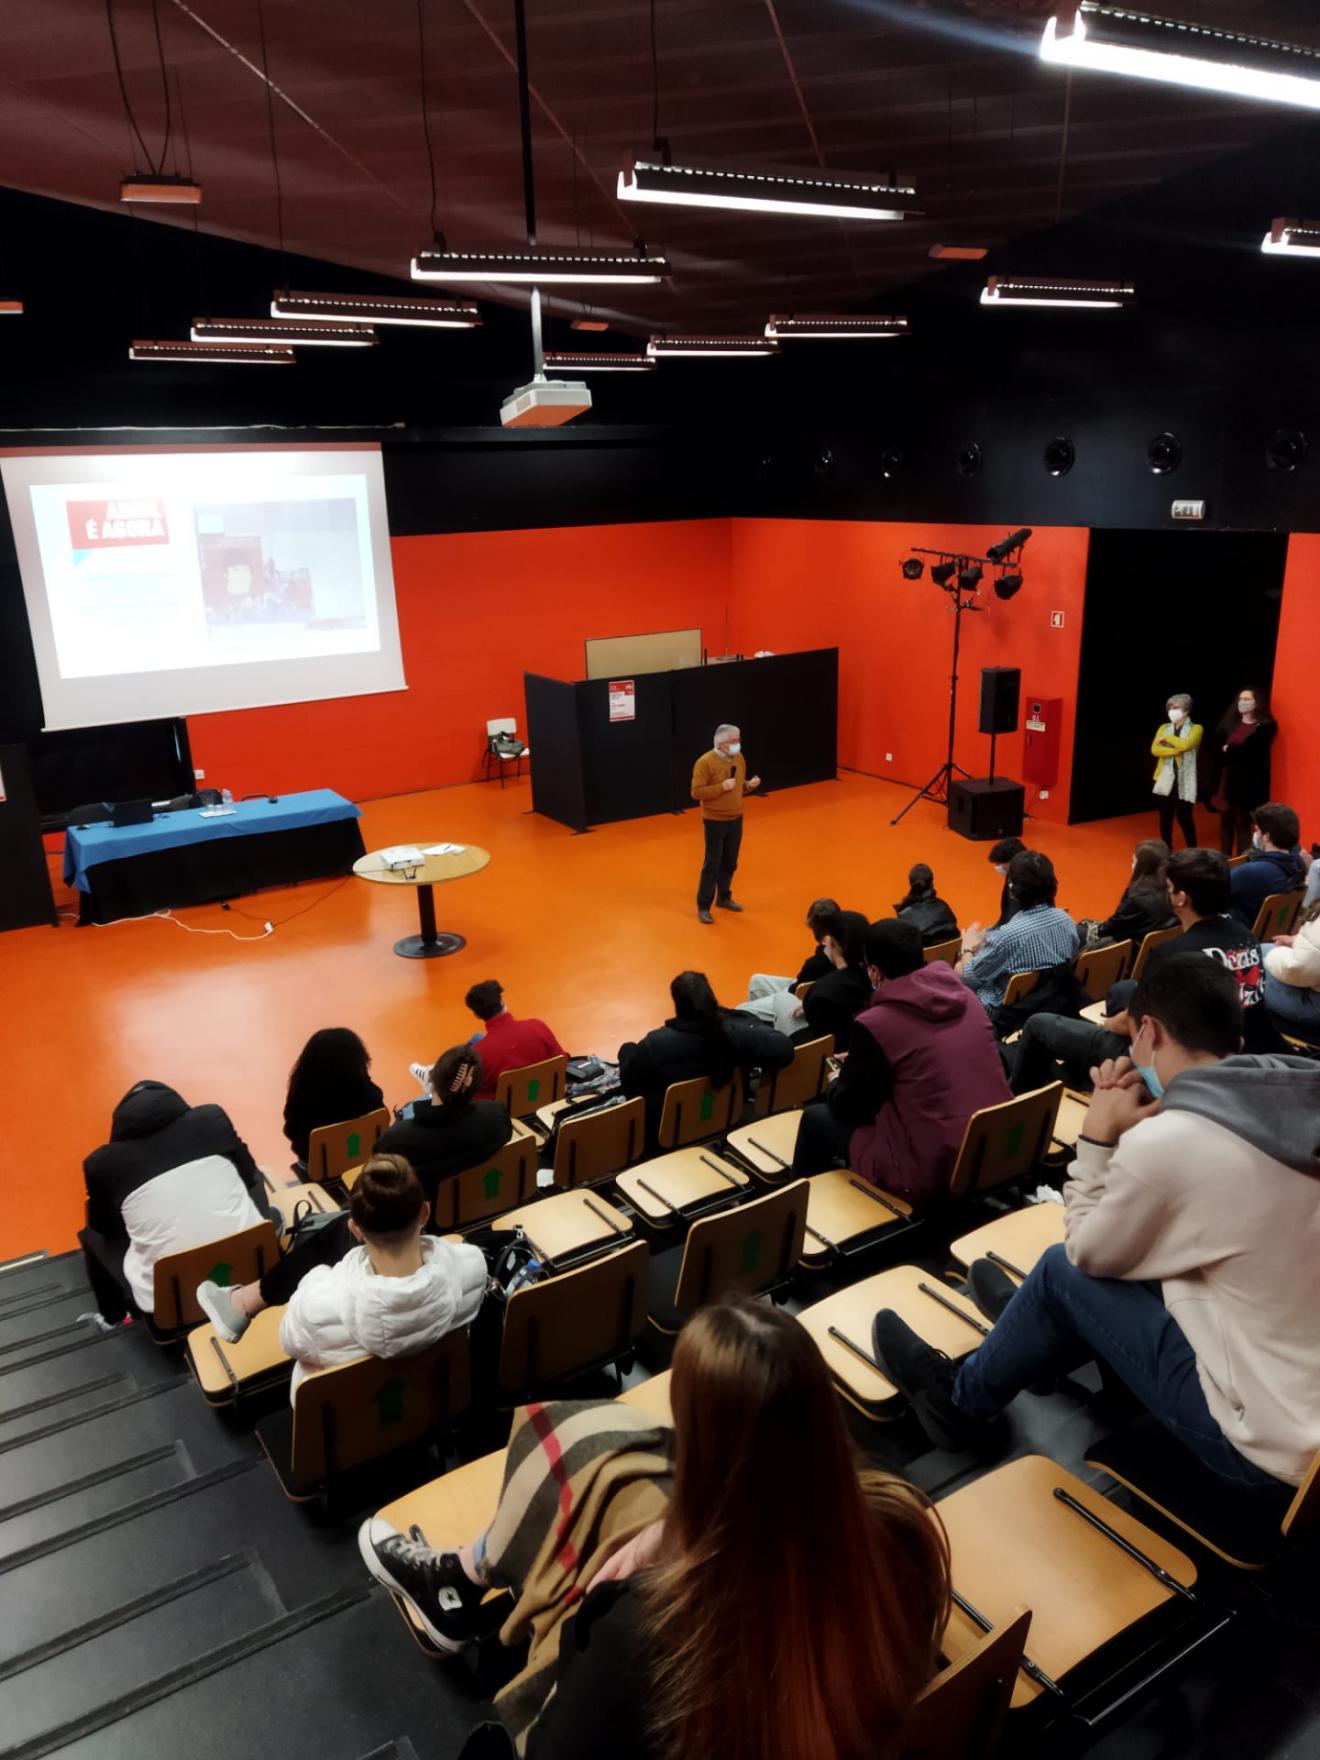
left=63, top=788, right=364, bottom=922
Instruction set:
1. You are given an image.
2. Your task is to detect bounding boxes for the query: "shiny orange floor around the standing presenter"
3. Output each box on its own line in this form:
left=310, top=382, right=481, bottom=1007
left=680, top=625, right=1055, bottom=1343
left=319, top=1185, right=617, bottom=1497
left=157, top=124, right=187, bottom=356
left=0, top=774, right=1155, bottom=1258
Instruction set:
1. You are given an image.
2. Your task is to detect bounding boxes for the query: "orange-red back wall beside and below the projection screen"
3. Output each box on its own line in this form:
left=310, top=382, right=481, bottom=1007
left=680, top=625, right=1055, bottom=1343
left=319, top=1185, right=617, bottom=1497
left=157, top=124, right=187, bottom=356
left=188, top=519, right=730, bottom=801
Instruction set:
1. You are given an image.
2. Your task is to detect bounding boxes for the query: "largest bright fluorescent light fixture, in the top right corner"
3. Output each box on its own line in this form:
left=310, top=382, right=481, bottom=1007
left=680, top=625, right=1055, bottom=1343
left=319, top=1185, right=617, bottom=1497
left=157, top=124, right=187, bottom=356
left=1040, top=0, right=1320, bottom=109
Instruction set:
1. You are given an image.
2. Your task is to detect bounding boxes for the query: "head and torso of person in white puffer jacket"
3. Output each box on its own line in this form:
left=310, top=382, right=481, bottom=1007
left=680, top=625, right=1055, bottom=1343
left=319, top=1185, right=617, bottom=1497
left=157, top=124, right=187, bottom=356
left=280, top=1155, right=488, bottom=1397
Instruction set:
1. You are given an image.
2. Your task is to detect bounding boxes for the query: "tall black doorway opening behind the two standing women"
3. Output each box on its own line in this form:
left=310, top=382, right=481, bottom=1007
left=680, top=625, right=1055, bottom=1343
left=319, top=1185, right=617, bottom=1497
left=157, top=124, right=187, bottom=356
left=1070, top=532, right=1288, bottom=836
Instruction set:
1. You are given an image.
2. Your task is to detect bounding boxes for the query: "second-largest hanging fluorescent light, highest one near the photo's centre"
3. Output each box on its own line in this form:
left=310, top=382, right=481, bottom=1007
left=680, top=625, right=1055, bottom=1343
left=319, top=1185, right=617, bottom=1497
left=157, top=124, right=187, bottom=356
left=618, top=157, right=917, bottom=220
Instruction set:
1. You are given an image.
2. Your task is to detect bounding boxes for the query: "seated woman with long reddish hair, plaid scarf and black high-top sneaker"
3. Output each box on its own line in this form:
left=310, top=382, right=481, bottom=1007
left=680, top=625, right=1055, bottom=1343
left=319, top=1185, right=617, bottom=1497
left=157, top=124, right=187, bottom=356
left=359, top=1295, right=949, bottom=1760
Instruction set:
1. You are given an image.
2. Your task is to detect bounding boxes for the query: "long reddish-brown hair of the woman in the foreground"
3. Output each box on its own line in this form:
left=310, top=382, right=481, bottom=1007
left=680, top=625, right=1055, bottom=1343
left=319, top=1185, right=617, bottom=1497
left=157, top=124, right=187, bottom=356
left=637, top=1297, right=949, bottom=1760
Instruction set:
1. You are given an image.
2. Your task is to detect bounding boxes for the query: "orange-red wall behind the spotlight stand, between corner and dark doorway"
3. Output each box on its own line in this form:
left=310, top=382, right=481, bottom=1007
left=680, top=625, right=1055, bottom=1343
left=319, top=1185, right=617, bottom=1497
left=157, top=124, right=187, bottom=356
left=730, top=519, right=1089, bottom=822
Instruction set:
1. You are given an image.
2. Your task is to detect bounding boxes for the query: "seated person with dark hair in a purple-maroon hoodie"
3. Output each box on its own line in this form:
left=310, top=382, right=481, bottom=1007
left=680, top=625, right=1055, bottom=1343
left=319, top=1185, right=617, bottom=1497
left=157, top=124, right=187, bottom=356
left=792, top=920, right=1012, bottom=1206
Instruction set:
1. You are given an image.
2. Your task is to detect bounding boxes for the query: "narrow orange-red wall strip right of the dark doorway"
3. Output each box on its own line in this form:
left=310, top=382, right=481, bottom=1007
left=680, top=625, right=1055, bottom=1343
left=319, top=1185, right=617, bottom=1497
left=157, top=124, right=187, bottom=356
left=1271, top=532, right=1320, bottom=847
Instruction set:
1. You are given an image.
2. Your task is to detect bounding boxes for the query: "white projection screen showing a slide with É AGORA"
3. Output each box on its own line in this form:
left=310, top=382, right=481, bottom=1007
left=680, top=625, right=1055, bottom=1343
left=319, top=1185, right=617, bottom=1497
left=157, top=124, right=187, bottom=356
left=0, top=447, right=403, bottom=727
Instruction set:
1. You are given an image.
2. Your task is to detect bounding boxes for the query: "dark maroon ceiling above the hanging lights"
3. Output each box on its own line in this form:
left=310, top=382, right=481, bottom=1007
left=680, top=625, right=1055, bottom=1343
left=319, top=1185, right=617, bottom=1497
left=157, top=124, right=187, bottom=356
left=0, top=0, right=1318, bottom=334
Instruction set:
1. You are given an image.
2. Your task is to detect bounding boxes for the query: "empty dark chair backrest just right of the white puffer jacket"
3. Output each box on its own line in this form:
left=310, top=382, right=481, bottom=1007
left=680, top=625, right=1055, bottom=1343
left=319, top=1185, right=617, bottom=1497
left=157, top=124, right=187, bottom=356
left=498, top=1241, right=651, bottom=1404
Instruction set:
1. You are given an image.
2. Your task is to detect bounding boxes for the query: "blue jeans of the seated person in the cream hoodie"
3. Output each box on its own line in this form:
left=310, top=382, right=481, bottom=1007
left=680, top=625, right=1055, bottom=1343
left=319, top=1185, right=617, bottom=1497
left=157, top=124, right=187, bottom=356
left=954, top=1246, right=1292, bottom=1501
